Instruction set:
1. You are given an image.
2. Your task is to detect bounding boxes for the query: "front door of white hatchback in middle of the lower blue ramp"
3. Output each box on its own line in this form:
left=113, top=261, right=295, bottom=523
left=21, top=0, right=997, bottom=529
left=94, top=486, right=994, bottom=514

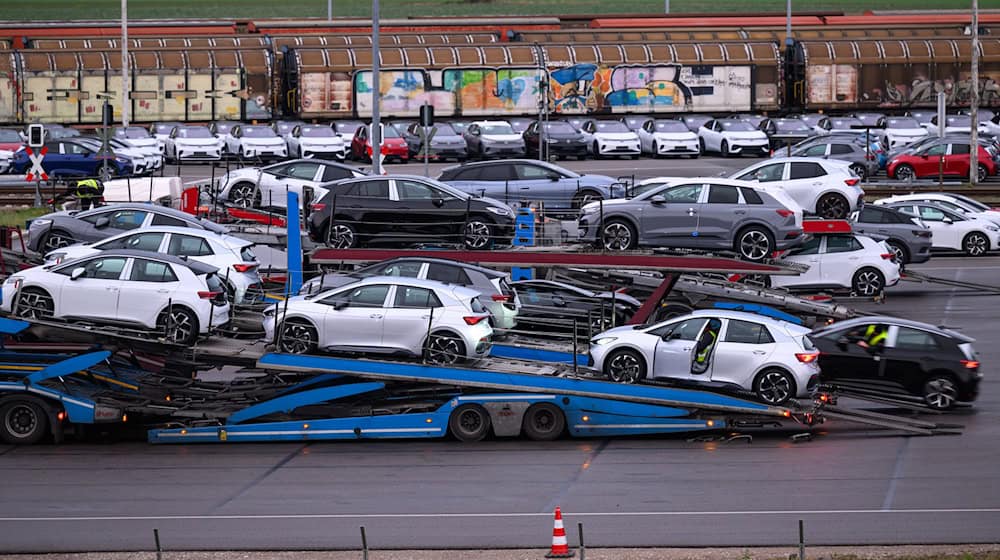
left=319, top=284, right=391, bottom=348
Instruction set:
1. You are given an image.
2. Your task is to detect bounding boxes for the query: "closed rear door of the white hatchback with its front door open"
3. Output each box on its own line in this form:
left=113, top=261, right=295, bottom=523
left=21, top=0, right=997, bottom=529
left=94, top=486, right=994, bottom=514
left=709, top=319, right=777, bottom=389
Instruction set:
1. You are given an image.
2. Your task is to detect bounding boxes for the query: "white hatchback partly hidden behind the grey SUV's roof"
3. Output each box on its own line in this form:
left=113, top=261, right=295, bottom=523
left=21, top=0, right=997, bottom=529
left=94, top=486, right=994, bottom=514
left=729, top=157, right=865, bottom=219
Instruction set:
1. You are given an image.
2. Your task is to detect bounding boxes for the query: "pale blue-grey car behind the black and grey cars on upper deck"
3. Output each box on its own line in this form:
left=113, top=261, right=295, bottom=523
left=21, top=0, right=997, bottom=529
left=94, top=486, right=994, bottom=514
left=438, top=159, right=625, bottom=209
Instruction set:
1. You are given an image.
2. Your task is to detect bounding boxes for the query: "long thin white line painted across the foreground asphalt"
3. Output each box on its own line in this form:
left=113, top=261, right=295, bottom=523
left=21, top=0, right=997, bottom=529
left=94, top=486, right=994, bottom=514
left=0, top=508, right=1000, bottom=523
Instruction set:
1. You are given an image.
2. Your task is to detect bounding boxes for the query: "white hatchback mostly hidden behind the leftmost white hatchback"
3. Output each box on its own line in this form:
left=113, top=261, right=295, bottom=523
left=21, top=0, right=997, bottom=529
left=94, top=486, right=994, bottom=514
left=45, top=226, right=263, bottom=303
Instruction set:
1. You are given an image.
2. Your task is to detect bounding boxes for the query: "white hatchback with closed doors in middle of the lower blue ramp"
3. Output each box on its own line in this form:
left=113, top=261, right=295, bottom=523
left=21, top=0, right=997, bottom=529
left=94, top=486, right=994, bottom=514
left=264, top=276, right=493, bottom=364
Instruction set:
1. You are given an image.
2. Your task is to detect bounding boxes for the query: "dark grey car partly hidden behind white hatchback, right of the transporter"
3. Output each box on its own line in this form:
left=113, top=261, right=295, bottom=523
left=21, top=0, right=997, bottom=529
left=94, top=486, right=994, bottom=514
left=850, top=206, right=931, bottom=264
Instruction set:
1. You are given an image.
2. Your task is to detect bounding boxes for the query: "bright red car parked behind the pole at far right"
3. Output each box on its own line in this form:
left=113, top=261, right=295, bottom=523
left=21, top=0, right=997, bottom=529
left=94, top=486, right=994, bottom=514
left=885, top=139, right=997, bottom=182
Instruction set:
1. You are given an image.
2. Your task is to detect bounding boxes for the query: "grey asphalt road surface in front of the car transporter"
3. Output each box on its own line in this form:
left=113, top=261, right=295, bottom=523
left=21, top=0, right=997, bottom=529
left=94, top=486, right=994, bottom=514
left=0, top=258, right=1000, bottom=552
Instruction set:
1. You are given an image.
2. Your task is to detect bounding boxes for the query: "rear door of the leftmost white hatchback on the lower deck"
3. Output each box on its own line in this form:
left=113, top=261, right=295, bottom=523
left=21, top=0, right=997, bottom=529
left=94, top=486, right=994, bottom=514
left=118, top=258, right=184, bottom=327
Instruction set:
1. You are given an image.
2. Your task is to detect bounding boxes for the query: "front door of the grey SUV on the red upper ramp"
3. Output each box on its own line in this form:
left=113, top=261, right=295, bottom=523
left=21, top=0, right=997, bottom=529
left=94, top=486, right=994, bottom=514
left=639, top=183, right=705, bottom=247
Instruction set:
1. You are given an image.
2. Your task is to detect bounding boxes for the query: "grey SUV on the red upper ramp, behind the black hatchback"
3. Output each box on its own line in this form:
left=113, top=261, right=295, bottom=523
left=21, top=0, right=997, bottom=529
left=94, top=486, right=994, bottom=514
left=579, top=178, right=803, bottom=260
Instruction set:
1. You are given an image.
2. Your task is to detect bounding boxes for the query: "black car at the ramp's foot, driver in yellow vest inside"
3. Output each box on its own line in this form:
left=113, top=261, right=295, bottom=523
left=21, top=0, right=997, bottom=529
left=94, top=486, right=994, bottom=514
left=809, top=316, right=982, bottom=410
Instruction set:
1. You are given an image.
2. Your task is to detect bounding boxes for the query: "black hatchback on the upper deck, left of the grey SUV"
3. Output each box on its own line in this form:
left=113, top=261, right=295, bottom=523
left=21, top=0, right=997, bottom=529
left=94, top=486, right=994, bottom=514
left=309, top=175, right=514, bottom=249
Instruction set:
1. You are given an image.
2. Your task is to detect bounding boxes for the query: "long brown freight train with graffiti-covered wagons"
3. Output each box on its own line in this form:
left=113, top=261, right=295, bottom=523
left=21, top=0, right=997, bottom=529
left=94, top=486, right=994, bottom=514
left=0, top=14, right=1000, bottom=125
